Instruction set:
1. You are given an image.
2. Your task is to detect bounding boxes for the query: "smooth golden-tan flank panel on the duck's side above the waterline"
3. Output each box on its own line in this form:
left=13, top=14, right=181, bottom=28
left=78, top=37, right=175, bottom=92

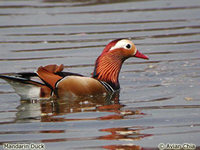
left=56, top=76, right=107, bottom=98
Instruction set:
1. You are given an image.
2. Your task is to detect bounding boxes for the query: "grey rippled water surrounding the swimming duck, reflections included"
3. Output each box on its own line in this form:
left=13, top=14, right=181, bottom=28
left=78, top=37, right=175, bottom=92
left=0, top=0, right=200, bottom=150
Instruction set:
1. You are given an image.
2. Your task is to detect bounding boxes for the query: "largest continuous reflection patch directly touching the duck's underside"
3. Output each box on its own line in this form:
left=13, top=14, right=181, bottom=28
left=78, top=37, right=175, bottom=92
left=15, top=92, right=140, bottom=122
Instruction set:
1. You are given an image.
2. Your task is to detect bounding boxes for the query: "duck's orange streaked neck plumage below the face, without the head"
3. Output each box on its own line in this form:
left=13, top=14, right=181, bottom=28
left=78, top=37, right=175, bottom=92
left=93, top=54, right=124, bottom=90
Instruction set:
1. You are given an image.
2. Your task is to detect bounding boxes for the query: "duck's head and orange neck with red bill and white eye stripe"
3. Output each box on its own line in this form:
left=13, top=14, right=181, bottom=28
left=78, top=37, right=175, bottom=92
left=93, top=39, right=148, bottom=90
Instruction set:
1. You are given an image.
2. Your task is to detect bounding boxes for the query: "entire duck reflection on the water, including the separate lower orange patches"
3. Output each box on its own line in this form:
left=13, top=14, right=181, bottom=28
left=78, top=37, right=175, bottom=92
left=15, top=91, right=152, bottom=150
